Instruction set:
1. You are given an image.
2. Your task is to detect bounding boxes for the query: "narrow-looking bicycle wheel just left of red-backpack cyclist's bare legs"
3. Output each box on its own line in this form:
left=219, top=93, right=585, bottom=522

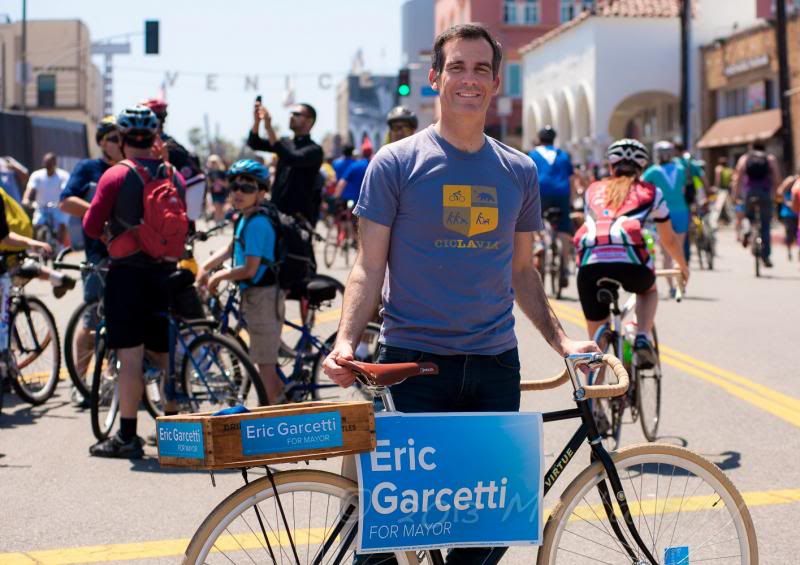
left=89, top=339, right=119, bottom=441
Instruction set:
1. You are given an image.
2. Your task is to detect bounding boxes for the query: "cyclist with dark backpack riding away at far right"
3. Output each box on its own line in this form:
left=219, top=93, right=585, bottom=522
left=733, top=141, right=783, bottom=267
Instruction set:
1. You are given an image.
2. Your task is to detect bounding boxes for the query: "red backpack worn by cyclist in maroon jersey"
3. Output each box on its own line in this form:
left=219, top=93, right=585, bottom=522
left=108, top=159, right=189, bottom=261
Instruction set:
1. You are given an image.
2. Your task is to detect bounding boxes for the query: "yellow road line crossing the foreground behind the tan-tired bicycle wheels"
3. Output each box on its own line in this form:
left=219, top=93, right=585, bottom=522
left=0, top=489, right=800, bottom=565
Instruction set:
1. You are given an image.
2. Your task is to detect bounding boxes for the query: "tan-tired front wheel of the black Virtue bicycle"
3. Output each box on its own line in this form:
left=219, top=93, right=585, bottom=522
left=537, top=444, right=758, bottom=565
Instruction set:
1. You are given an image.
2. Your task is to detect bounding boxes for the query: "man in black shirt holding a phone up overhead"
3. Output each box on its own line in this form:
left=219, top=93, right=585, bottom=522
left=247, top=102, right=323, bottom=224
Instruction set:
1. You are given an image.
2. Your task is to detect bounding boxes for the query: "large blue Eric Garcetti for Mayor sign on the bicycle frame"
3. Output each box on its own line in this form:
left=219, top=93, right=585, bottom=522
left=358, top=413, right=544, bottom=553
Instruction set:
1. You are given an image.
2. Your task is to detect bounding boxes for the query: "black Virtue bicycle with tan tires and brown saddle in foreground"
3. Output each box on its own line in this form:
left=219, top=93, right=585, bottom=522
left=183, top=354, right=758, bottom=565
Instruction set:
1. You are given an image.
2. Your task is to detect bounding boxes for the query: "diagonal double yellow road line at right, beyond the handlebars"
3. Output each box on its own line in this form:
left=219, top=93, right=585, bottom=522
left=551, top=302, right=800, bottom=427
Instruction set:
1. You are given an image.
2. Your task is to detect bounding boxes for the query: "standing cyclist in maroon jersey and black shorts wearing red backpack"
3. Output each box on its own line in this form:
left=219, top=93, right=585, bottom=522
left=83, top=106, right=189, bottom=458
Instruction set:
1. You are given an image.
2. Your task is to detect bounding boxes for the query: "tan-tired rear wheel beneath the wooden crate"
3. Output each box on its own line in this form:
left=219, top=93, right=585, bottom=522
left=183, top=471, right=358, bottom=565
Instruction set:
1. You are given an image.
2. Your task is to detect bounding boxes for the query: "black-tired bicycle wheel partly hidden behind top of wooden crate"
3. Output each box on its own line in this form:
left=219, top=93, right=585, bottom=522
left=178, top=334, right=268, bottom=411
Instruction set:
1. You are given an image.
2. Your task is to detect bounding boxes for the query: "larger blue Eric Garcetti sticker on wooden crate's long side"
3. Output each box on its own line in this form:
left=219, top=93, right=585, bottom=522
left=241, top=411, right=343, bottom=455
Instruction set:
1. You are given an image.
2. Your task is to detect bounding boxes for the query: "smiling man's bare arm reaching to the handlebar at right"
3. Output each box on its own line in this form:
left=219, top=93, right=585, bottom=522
left=511, top=232, right=600, bottom=357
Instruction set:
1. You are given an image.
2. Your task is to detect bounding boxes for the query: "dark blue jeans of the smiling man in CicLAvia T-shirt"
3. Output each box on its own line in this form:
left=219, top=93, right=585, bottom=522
left=355, top=345, right=520, bottom=565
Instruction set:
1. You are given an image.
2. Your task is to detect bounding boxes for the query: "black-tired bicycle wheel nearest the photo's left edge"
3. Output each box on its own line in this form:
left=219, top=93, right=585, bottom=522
left=9, top=295, right=61, bottom=405
